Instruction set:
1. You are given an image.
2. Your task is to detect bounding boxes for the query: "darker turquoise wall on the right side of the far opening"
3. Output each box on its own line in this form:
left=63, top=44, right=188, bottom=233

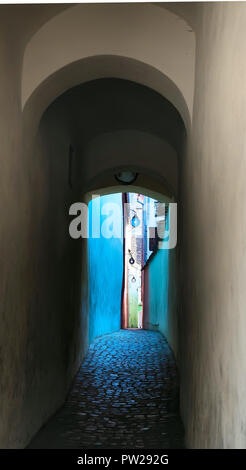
left=144, top=249, right=178, bottom=357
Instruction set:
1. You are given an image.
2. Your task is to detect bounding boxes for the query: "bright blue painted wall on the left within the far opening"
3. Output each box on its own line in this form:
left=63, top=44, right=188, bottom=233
left=88, top=193, right=123, bottom=343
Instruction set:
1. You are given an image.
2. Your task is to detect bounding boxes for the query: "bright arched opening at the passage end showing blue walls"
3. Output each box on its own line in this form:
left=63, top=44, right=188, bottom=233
left=86, top=187, right=173, bottom=343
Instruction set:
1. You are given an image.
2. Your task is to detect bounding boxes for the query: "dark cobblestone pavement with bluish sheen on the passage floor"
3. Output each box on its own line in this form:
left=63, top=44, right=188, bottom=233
left=29, top=330, right=183, bottom=449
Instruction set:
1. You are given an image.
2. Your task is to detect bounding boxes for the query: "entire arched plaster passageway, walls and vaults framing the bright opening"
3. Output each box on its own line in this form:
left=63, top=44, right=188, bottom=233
left=0, top=2, right=246, bottom=448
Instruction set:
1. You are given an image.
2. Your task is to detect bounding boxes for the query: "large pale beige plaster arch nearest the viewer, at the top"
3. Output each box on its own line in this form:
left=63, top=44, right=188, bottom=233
left=22, top=4, right=195, bottom=127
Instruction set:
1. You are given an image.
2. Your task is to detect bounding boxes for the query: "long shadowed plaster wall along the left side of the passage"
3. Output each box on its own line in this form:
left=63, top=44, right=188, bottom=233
left=0, top=22, right=86, bottom=448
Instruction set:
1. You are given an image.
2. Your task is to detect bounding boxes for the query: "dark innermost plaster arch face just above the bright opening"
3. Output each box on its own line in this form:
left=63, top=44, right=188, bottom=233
left=83, top=130, right=178, bottom=194
